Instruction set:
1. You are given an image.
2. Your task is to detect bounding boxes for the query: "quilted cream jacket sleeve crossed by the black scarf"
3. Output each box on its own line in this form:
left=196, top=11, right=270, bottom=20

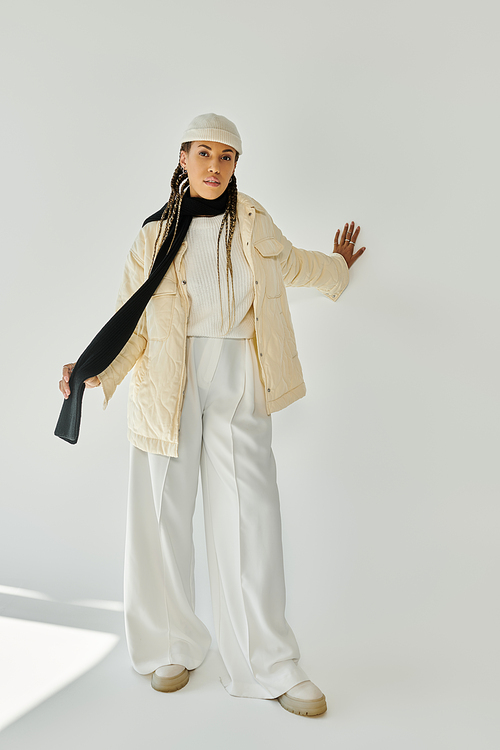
left=99, top=230, right=147, bottom=409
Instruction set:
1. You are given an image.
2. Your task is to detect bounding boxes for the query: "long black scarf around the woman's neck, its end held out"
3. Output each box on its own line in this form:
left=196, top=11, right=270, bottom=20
left=54, top=189, right=228, bottom=444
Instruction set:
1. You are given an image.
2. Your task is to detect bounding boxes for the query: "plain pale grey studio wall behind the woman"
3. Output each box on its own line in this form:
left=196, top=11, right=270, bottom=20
left=0, top=0, right=499, bottom=740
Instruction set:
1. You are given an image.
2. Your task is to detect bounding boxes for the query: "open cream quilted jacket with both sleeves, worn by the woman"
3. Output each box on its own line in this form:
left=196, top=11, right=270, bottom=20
left=99, top=193, right=349, bottom=456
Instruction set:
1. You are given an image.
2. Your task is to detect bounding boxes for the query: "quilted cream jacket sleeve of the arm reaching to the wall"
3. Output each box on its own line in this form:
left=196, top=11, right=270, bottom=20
left=273, top=224, right=349, bottom=300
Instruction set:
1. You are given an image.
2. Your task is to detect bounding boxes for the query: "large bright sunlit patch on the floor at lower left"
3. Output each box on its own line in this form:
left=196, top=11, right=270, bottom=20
left=0, top=617, right=119, bottom=730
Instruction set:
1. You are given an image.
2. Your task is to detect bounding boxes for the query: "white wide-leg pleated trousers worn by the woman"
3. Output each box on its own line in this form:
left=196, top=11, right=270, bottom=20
left=124, top=337, right=308, bottom=698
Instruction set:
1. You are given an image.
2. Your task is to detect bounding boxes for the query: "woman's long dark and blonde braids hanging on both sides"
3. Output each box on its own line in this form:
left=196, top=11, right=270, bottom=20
left=150, top=142, right=239, bottom=333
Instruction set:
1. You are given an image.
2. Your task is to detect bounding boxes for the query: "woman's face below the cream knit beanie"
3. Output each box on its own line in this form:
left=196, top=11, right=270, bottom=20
left=179, top=141, right=236, bottom=200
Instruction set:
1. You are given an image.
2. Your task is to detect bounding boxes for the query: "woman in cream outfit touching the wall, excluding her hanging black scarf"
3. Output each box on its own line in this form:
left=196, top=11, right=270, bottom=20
left=59, top=114, right=365, bottom=716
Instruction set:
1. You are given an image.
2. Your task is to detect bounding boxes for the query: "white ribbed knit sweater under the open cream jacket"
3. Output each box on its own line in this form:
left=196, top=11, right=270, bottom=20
left=184, top=215, right=255, bottom=339
